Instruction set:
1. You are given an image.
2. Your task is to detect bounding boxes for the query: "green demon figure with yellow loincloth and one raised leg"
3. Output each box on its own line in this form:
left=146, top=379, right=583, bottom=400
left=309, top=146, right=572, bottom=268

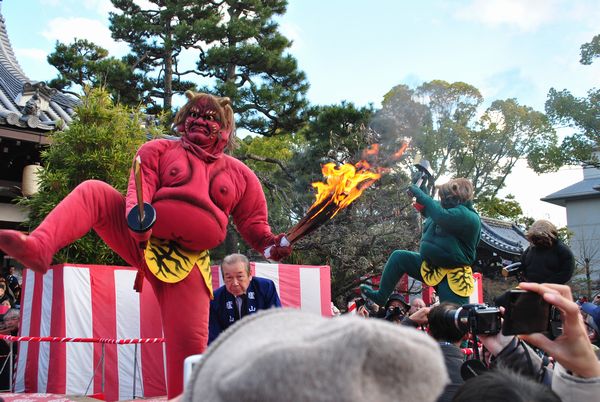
left=360, top=178, right=481, bottom=305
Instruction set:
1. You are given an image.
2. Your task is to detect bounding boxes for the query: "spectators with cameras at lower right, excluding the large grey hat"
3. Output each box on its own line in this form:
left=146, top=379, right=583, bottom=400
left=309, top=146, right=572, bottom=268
left=338, top=283, right=600, bottom=402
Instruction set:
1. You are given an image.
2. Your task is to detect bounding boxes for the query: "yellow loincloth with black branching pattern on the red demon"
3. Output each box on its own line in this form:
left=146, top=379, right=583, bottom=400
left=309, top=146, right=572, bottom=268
left=144, top=237, right=213, bottom=298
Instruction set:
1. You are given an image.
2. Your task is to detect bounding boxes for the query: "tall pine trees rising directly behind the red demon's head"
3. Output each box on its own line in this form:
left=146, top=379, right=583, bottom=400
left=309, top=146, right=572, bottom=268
left=110, top=0, right=308, bottom=132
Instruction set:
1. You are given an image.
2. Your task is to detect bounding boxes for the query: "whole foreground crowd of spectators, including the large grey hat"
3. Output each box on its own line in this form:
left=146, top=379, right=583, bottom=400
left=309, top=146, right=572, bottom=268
left=181, top=283, right=600, bottom=402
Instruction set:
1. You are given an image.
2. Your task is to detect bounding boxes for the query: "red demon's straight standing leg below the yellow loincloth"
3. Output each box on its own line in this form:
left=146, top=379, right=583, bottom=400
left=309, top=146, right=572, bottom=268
left=146, top=267, right=210, bottom=399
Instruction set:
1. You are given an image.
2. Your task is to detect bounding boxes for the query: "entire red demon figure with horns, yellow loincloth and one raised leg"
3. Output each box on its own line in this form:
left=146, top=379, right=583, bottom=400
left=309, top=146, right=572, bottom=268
left=0, top=92, right=291, bottom=398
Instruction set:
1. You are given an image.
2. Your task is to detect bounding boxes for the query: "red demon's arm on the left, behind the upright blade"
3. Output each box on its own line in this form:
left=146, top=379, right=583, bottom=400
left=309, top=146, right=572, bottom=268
left=126, top=140, right=168, bottom=214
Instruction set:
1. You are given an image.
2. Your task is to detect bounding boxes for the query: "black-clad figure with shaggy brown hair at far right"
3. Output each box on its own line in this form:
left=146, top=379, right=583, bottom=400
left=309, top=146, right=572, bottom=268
left=521, top=219, right=575, bottom=284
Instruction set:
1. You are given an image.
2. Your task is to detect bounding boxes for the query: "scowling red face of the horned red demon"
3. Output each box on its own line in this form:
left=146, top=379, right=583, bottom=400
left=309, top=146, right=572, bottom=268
left=178, top=98, right=230, bottom=156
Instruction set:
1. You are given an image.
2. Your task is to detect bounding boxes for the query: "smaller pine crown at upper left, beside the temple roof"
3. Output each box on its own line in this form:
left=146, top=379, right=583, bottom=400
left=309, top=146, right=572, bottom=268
left=48, top=39, right=151, bottom=106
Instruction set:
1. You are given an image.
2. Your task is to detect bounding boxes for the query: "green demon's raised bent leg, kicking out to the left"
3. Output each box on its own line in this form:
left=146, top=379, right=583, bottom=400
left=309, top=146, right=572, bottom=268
left=360, top=250, right=423, bottom=306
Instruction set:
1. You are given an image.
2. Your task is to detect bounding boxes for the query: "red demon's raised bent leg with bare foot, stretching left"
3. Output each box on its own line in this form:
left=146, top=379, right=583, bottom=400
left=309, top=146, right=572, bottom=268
left=0, top=180, right=141, bottom=273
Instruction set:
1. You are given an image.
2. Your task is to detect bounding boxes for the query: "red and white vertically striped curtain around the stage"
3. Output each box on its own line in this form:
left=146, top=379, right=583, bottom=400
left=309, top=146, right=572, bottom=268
left=15, top=263, right=331, bottom=401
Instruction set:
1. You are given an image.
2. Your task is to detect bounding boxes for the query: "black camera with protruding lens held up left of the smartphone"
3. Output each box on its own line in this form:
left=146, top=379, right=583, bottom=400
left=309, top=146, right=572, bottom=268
left=446, top=304, right=502, bottom=335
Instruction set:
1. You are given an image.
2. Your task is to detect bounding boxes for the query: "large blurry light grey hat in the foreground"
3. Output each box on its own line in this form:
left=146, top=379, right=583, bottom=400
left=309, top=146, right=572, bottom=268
left=181, top=309, right=448, bottom=402
